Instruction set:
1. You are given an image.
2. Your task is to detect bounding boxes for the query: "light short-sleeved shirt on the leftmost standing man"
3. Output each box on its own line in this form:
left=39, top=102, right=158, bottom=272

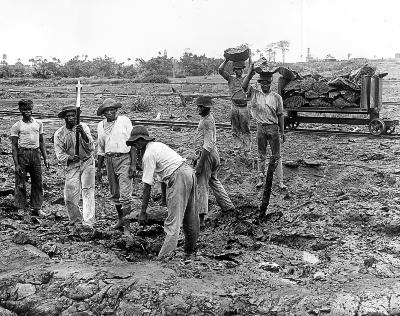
left=10, top=118, right=43, bottom=149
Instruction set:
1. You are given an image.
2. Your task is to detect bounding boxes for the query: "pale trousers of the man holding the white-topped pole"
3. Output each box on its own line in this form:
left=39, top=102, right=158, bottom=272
left=64, top=158, right=95, bottom=227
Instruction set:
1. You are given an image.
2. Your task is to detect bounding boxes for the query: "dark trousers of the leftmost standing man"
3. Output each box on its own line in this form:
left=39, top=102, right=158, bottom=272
left=14, top=148, right=43, bottom=210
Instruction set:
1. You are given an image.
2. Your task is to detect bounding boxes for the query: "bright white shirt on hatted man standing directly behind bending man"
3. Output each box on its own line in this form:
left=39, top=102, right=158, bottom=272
left=97, top=115, right=132, bottom=156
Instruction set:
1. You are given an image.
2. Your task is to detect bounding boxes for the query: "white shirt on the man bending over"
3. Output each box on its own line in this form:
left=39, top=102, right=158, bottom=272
left=142, top=142, right=186, bottom=185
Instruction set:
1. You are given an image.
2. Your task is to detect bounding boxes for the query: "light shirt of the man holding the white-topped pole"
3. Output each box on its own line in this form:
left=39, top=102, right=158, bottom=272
left=54, top=123, right=94, bottom=164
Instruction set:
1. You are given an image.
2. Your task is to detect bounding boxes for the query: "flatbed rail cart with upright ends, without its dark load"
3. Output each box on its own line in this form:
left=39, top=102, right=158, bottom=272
left=278, top=76, right=399, bottom=135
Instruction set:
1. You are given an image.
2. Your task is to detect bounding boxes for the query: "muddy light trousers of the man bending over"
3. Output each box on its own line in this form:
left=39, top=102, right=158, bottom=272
left=158, top=163, right=200, bottom=257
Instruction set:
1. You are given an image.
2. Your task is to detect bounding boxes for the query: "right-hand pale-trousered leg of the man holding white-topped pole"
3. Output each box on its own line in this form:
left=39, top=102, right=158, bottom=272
left=81, top=158, right=96, bottom=227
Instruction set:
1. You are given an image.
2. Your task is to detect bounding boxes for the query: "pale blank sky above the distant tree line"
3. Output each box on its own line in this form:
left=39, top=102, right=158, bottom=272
left=0, top=0, right=400, bottom=64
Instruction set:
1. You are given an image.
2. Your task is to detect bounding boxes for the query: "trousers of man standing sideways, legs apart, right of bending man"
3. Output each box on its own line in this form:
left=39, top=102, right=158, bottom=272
left=196, top=153, right=235, bottom=214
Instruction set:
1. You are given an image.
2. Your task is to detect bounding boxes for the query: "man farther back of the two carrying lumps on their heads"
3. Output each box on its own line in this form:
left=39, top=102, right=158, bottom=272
left=218, top=59, right=251, bottom=154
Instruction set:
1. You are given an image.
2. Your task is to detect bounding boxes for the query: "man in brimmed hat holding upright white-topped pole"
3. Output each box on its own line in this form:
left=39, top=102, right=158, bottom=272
left=54, top=105, right=95, bottom=234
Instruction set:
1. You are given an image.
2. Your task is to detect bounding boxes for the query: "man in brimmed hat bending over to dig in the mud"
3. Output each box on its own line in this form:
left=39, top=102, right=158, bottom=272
left=126, top=125, right=199, bottom=258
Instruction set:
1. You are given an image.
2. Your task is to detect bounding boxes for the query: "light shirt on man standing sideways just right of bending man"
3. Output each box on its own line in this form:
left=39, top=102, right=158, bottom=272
left=194, top=113, right=218, bottom=154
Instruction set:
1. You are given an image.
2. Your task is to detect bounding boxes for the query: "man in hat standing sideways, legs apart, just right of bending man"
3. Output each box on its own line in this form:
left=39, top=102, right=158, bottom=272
left=195, top=95, right=235, bottom=228
